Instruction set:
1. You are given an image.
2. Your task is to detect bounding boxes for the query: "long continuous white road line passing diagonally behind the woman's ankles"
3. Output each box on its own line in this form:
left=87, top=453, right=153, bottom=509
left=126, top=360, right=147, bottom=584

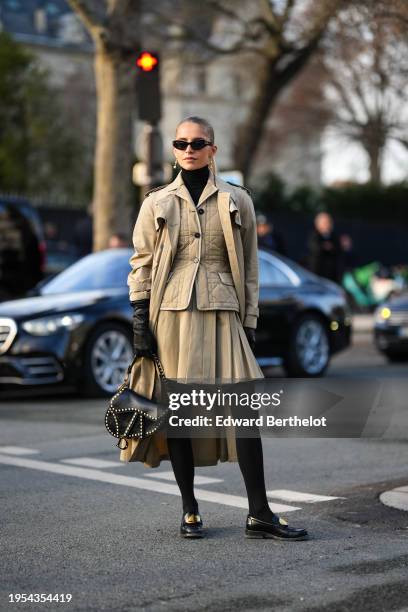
left=0, top=454, right=300, bottom=512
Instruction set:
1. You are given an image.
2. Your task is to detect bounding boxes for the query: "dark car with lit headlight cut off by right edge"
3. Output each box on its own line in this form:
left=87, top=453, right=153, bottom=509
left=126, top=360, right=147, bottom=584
left=374, top=292, right=408, bottom=362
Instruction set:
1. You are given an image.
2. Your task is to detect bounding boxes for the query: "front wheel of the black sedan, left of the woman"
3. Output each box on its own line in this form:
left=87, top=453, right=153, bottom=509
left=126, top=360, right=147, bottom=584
left=83, top=322, right=133, bottom=397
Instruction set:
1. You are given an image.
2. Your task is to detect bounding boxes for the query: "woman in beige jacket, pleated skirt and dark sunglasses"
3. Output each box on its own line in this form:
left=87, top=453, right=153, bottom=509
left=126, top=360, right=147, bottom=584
left=120, top=117, right=307, bottom=540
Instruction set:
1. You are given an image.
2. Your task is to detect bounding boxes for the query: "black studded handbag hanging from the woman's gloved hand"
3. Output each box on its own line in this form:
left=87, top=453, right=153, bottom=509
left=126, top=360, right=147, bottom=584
left=105, top=355, right=171, bottom=450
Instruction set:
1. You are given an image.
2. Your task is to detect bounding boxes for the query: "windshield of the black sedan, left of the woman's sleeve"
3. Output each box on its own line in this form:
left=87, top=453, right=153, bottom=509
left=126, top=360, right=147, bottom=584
left=41, top=249, right=132, bottom=295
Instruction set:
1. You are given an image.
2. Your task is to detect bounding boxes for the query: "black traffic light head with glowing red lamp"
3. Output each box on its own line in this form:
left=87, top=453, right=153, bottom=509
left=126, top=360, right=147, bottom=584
left=136, top=51, right=161, bottom=125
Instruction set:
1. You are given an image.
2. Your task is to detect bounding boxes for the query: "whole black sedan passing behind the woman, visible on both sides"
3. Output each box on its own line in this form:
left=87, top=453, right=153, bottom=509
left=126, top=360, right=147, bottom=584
left=0, top=249, right=351, bottom=395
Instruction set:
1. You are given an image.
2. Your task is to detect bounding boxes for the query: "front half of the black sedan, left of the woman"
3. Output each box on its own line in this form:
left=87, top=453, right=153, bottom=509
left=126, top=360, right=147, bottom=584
left=0, top=249, right=133, bottom=396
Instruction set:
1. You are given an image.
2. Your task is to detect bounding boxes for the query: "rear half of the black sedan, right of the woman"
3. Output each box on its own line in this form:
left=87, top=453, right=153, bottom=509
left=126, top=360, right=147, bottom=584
left=255, top=249, right=352, bottom=377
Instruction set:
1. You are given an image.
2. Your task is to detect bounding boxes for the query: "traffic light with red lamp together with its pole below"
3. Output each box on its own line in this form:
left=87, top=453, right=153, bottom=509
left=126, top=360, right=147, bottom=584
left=136, top=51, right=163, bottom=196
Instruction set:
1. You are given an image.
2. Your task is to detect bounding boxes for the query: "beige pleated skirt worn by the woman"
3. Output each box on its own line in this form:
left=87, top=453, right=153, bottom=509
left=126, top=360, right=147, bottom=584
left=120, top=289, right=264, bottom=467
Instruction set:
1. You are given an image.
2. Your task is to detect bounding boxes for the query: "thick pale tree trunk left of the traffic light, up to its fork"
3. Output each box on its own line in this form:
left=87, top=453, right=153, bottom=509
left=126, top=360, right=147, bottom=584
left=68, top=0, right=140, bottom=251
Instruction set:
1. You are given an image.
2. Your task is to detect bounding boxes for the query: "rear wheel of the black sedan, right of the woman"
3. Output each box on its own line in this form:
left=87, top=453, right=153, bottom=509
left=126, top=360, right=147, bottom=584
left=283, top=314, right=330, bottom=378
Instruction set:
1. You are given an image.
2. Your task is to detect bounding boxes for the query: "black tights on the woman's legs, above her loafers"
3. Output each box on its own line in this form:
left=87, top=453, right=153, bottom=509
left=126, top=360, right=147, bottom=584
left=167, top=431, right=274, bottom=521
